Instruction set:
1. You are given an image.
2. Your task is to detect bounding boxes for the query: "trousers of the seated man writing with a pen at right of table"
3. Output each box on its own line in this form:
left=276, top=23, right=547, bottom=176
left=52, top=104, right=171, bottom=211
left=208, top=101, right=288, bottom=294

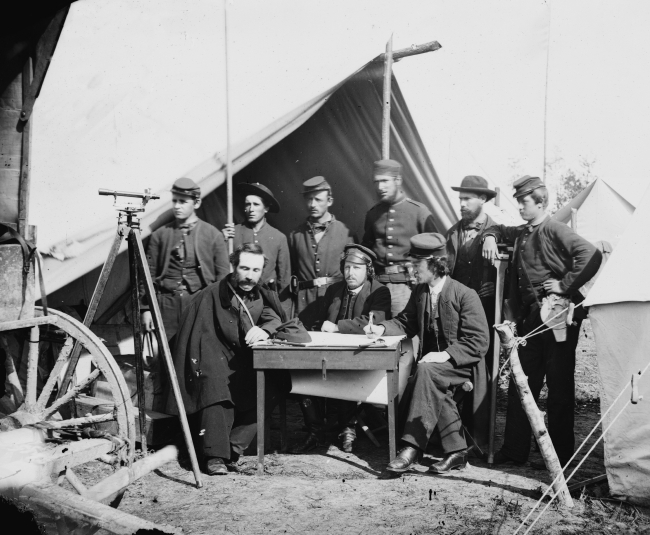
left=400, top=361, right=472, bottom=453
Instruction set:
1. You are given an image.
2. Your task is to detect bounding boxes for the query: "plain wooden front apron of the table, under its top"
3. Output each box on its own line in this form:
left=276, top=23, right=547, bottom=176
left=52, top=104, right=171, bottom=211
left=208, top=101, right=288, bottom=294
left=253, top=349, right=399, bottom=370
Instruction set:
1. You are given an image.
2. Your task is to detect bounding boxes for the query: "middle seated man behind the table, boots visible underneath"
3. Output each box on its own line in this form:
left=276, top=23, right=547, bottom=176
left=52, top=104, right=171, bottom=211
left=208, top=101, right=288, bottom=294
left=291, top=244, right=391, bottom=454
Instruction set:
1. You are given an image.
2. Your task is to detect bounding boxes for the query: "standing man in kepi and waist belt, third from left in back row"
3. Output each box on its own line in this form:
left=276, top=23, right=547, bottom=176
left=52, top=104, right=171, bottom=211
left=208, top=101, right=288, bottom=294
left=289, top=176, right=354, bottom=329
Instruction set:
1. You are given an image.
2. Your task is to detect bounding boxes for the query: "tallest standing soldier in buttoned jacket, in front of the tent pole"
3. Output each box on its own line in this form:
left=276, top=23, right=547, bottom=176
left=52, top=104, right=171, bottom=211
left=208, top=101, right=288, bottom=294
left=362, top=160, right=436, bottom=316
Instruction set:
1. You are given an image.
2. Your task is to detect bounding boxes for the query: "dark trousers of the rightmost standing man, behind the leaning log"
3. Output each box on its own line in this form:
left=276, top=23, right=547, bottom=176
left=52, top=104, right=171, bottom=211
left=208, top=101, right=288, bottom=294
left=502, top=320, right=581, bottom=465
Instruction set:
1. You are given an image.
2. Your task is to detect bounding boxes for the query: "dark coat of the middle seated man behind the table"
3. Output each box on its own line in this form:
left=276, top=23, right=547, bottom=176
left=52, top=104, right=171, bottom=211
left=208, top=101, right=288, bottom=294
left=311, top=279, right=391, bottom=334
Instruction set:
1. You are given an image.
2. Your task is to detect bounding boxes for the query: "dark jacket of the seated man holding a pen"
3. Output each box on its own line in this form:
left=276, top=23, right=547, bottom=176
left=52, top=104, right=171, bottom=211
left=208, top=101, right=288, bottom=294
left=382, top=277, right=490, bottom=444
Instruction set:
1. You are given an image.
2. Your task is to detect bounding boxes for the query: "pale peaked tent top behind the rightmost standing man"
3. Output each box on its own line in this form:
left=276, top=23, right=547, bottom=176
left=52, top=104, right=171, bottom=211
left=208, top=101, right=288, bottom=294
left=553, top=178, right=634, bottom=247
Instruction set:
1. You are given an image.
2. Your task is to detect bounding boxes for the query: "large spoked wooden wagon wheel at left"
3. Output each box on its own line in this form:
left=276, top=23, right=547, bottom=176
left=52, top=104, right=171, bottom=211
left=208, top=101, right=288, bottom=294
left=0, top=307, right=136, bottom=520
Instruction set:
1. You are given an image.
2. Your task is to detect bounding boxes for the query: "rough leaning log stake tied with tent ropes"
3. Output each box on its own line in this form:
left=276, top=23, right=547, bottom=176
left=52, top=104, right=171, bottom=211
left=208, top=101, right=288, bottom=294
left=495, top=321, right=573, bottom=507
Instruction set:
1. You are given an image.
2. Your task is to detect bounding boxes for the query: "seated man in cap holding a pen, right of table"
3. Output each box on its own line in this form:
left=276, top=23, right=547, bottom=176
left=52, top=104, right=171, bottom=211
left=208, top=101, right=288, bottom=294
left=364, top=233, right=490, bottom=474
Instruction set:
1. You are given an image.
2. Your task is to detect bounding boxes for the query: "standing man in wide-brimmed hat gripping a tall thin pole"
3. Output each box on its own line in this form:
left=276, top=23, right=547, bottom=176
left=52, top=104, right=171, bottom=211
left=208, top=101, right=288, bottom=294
left=223, top=182, right=291, bottom=302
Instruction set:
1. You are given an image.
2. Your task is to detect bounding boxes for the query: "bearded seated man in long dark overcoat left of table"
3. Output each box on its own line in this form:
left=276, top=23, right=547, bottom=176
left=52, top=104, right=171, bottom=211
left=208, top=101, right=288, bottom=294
left=167, top=243, right=311, bottom=475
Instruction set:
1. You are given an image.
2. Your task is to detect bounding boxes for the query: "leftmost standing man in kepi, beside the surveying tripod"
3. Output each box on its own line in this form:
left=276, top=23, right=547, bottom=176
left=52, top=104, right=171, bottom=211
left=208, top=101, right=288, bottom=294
left=141, top=178, right=230, bottom=340
